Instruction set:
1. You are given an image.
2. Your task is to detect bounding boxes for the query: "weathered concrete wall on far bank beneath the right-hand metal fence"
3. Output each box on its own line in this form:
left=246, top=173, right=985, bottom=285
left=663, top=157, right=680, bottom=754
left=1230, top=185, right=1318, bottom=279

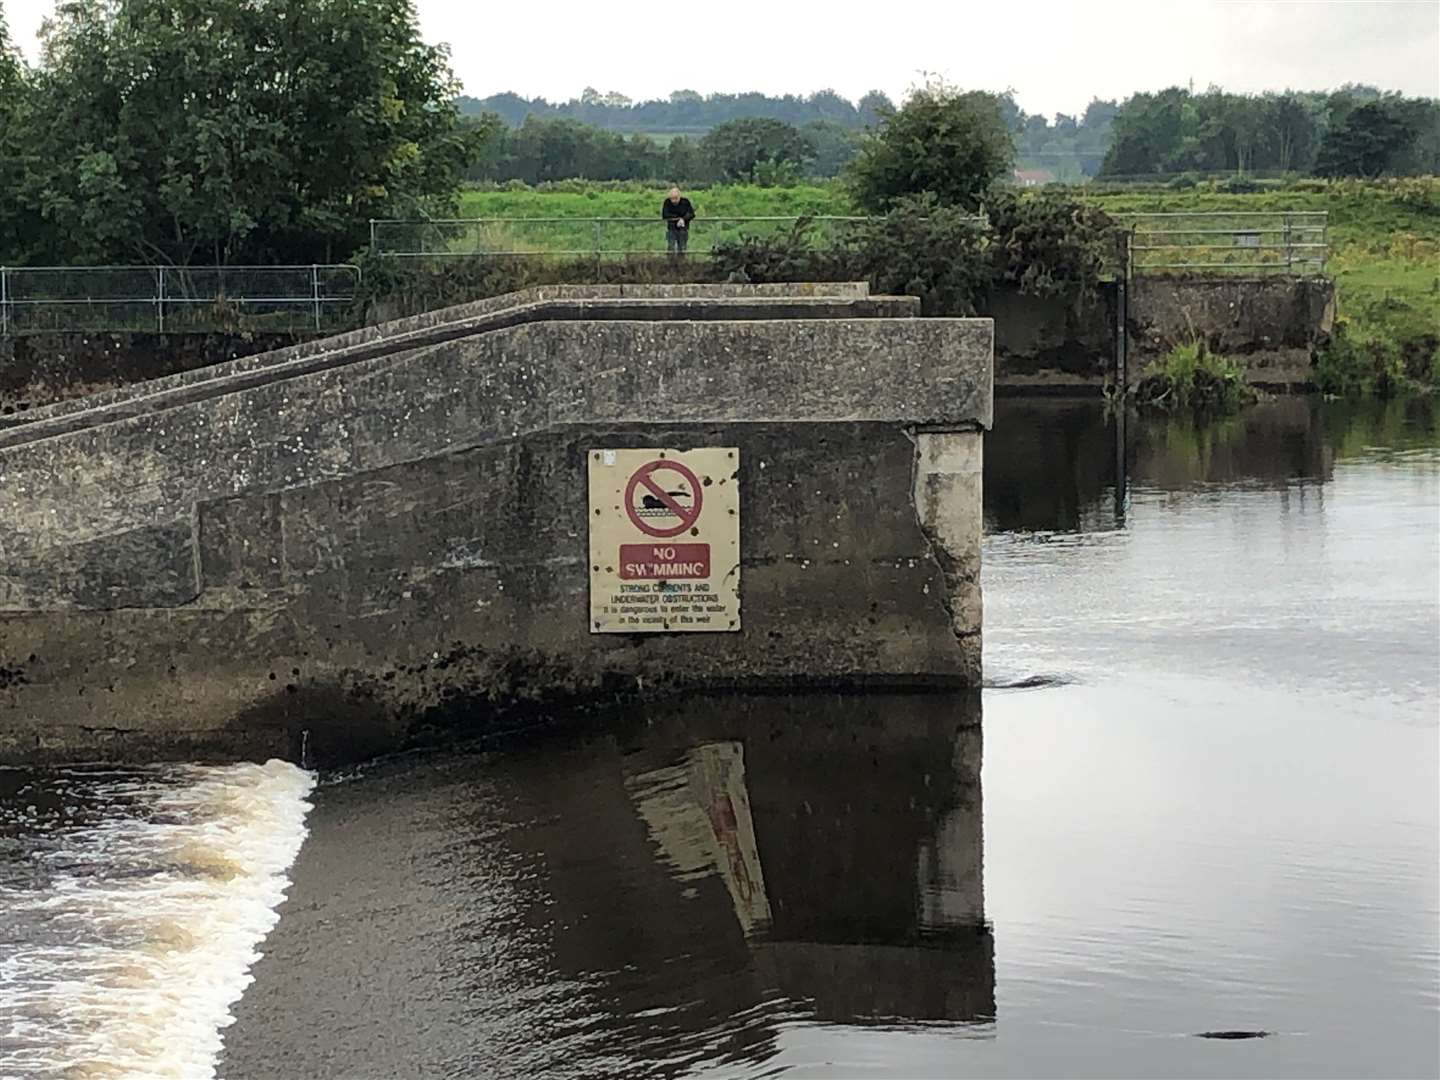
left=1129, top=275, right=1335, bottom=389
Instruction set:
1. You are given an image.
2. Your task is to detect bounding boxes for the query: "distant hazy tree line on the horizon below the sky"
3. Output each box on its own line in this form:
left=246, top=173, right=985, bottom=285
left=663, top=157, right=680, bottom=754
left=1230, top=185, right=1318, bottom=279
left=461, top=85, right=1440, bottom=184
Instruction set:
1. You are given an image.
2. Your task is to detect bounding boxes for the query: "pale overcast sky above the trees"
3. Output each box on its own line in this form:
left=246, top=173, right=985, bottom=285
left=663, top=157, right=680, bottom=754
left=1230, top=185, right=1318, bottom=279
left=0, top=0, right=1440, bottom=115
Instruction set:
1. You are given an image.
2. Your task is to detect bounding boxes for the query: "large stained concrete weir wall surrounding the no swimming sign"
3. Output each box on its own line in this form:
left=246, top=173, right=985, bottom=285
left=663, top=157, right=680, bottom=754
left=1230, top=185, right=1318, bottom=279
left=0, top=285, right=992, bottom=763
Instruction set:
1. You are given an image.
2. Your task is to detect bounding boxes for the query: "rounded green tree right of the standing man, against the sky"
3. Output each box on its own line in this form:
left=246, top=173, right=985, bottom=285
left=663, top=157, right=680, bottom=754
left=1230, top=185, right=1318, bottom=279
left=850, top=84, right=1015, bottom=212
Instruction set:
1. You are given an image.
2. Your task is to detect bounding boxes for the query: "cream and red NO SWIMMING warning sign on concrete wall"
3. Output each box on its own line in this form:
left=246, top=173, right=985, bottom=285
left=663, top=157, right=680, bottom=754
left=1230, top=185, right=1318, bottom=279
left=589, top=446, right=740, bottom=634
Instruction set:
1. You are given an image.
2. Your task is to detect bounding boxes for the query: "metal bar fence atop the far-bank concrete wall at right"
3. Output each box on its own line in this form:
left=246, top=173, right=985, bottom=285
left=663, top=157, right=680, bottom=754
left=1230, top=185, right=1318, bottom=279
left=1115, top=210, right=1329, bottom=274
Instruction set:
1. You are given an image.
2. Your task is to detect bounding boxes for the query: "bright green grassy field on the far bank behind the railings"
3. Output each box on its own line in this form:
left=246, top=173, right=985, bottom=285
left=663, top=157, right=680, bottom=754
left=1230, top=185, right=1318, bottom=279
left=462, top=177, right=1440, bottom=377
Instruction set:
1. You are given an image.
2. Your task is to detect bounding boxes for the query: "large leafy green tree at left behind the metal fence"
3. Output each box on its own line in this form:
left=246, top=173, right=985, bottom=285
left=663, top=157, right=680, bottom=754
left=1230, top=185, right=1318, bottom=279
left=26, top=0, right=475, bottom=264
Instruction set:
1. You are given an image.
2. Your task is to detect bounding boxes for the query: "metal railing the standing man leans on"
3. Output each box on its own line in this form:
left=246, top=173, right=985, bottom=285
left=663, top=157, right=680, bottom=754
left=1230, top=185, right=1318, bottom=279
left=370, top=215, right=870, bottom=259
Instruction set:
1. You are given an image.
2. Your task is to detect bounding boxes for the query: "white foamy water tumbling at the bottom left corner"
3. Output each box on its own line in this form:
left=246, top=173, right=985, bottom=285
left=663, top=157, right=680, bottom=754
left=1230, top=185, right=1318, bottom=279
left=0, top=760, right=314, bottom=1080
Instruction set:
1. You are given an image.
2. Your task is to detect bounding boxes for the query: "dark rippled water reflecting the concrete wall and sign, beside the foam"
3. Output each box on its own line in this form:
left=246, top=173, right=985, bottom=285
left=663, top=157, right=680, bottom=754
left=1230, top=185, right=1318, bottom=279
left=223, top=694, right=995, bottom=1077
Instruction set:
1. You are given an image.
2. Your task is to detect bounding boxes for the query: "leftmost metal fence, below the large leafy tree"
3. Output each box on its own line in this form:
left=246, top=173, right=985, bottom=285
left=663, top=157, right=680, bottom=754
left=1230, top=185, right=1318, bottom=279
left=0, top=264, right=360, bottom=336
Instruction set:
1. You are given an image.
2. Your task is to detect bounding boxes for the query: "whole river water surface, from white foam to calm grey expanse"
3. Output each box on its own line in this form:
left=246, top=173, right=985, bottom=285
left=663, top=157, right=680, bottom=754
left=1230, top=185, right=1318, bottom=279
left=0, top=399, right=1440, bottom=1080
